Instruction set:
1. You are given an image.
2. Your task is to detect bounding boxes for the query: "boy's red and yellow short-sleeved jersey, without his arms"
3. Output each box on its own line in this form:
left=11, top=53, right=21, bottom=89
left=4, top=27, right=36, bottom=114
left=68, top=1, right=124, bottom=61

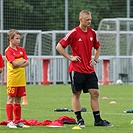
left=5, top=46, right=28, bottom=87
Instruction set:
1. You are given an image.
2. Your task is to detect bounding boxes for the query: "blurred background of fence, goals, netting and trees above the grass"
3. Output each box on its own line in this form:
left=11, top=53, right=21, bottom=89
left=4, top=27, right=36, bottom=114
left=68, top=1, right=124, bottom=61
left=0, top=0, right=133, bottom=84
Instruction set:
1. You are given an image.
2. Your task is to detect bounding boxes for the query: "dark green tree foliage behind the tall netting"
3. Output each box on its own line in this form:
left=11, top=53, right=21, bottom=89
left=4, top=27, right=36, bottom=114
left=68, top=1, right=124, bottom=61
left=4, top=0, right=129, bottom=31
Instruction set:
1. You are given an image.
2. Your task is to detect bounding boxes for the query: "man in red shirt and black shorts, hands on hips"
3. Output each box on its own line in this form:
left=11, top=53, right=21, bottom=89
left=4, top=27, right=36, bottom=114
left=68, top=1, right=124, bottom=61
left=56, top=10, right=113, bottom=127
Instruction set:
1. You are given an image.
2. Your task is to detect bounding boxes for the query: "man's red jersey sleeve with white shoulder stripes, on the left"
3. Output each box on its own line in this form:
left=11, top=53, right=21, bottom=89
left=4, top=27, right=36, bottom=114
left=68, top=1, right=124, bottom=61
left=59, top=29, right=76, bottom=48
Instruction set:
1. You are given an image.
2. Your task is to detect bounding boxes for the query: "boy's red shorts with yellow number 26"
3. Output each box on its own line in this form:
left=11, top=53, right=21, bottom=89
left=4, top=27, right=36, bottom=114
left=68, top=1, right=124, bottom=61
left=7, top=86, right=26, bottom=97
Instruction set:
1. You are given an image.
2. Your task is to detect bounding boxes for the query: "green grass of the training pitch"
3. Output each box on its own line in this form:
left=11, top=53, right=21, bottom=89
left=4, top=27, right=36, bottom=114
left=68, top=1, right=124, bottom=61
left=0, top=85, right=133, bottom=133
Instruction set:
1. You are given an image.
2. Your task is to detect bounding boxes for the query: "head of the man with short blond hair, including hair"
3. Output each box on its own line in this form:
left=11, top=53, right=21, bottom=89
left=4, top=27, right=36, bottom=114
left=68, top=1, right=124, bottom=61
left=79, top=10, right=92, bottom=27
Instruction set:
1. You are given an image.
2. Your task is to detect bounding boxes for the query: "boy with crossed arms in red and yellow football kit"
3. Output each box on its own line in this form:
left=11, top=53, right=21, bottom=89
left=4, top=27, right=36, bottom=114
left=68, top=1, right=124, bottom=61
left=5, top=29, right=29, bottom=128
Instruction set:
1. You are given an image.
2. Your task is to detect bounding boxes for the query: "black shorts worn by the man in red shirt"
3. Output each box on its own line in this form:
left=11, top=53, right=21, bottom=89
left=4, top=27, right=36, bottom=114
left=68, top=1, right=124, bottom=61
left=70, top=72, right=98, bottom=93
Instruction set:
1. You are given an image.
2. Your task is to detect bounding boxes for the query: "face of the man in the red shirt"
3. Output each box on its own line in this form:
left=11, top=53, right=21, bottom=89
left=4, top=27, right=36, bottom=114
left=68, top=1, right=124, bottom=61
left=81, top=14, right=92, bottom=27
